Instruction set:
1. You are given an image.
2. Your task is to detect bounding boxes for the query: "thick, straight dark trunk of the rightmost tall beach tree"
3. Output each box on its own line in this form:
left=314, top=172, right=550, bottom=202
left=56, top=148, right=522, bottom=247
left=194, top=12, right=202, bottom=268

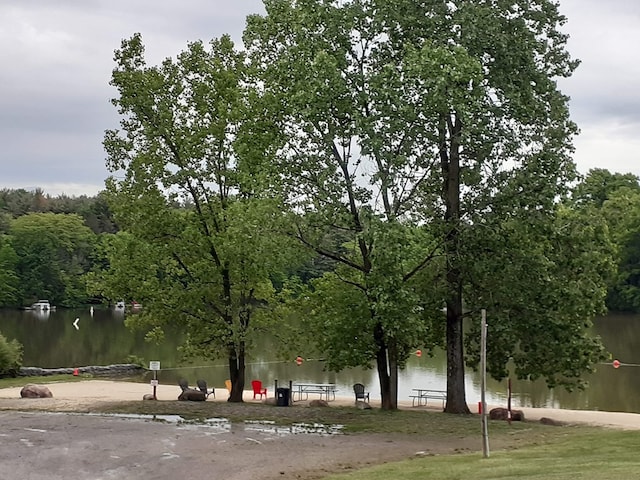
left=440, top=114, right=470, bottom=413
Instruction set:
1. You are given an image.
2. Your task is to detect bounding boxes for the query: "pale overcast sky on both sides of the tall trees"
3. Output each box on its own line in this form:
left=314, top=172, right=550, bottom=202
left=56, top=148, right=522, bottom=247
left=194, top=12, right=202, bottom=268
left=0, top=0, right=640, bottom=195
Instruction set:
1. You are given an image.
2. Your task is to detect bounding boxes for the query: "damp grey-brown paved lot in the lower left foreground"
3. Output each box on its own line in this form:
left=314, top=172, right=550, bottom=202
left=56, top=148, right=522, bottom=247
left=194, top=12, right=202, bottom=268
left=0, top=411, right=419, bottom=480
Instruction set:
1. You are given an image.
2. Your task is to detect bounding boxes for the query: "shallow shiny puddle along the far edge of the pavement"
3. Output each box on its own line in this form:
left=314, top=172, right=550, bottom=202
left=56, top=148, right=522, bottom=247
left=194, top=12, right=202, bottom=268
left=87, top=413, right=344, bottom=436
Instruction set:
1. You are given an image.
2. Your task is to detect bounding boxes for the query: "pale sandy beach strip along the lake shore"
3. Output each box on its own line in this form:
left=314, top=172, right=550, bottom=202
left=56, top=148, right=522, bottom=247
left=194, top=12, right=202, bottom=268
left=0, top=379, right=640, bottom=430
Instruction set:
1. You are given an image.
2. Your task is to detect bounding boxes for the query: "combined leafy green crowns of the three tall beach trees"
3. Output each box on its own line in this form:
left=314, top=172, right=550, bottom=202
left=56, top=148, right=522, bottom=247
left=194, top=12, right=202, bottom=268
left=91, top=0, right=612, bottom=412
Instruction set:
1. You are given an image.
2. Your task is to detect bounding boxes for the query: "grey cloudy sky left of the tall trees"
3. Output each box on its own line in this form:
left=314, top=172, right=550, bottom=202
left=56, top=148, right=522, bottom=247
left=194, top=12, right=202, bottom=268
left=0, top=0, right=262, bottom=194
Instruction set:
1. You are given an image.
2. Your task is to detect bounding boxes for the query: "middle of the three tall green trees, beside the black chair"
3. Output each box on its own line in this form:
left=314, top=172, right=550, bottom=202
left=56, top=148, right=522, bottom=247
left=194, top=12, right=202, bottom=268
left=245, top=1, right=458, bottom=409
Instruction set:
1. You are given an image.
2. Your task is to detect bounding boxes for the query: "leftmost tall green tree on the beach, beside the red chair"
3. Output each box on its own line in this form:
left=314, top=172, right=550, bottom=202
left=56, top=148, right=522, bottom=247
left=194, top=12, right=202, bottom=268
left=104, top=35, right=300, bottom=402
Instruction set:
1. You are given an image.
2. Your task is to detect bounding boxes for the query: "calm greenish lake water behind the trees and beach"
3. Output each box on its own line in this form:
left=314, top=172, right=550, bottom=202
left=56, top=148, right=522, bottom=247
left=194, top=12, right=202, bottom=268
left=0, top=309, right=640, bottom=413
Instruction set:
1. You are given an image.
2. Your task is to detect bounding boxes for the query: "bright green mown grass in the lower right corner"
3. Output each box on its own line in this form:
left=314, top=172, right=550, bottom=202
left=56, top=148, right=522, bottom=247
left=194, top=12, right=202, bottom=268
left=325, top=427, right=640, bottom=480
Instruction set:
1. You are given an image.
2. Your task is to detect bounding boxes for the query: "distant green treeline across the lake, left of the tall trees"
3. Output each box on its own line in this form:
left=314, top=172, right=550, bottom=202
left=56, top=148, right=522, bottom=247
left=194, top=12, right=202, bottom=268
left=0, top=189, right=332, bottom=308
